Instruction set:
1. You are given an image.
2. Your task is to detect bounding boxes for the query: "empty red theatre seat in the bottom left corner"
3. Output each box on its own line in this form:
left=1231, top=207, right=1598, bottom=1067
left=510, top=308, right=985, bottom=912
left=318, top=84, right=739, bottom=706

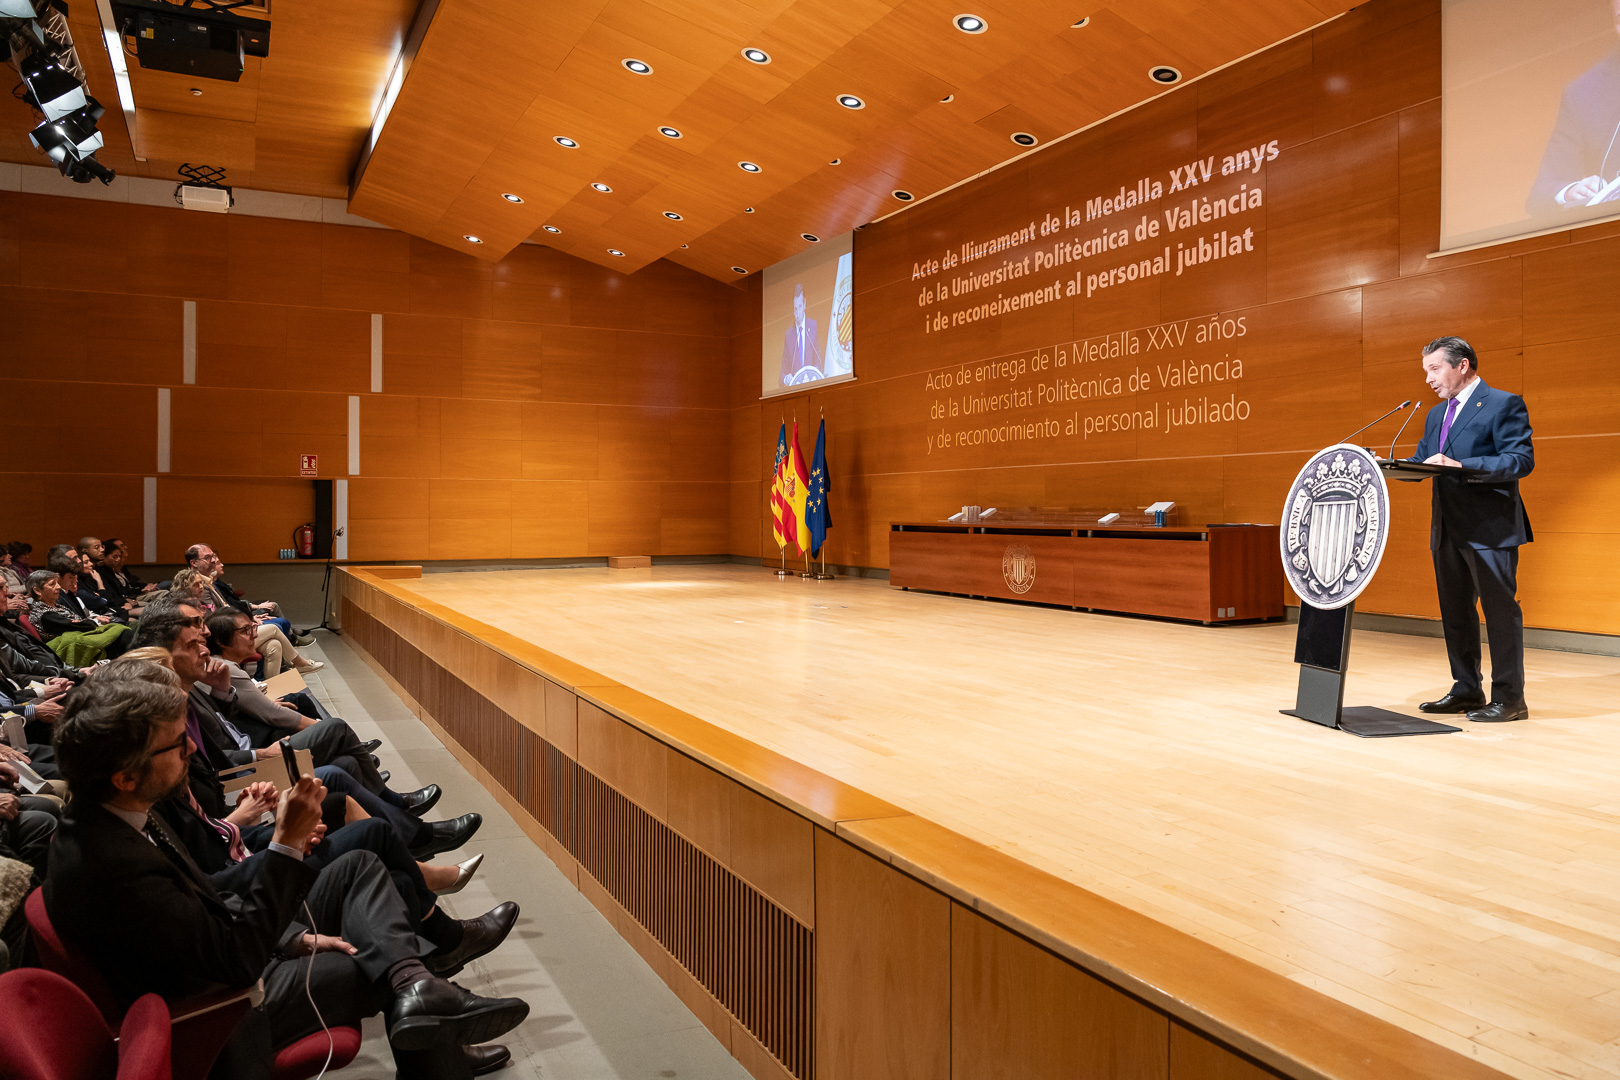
left=0, top=968, right=170, bottom=1080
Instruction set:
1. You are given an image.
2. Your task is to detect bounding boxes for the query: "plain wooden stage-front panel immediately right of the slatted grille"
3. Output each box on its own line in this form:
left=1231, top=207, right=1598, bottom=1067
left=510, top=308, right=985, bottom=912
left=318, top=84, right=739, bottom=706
left=815, top=829, right=951, bottom=1080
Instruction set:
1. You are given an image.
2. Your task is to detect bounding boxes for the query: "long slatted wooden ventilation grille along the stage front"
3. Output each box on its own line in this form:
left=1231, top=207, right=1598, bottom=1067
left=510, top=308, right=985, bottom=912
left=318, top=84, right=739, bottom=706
left=343, top=596, right=815, bottom=1080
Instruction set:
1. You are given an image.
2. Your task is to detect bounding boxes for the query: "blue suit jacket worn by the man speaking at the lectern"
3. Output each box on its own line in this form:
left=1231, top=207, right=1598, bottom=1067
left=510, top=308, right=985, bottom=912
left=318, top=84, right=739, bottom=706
left=1409, top=379, right=1536, bottom=549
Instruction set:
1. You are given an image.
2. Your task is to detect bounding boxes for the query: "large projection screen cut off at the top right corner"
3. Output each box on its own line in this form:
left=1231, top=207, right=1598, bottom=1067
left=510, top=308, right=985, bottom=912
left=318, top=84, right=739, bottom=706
left=1440, top=0, right=1620, bottom=251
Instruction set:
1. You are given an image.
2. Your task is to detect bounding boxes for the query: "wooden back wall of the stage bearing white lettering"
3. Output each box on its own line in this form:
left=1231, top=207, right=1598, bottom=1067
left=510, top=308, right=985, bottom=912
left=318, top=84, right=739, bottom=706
left=729, top=0, right=1620, bottom=633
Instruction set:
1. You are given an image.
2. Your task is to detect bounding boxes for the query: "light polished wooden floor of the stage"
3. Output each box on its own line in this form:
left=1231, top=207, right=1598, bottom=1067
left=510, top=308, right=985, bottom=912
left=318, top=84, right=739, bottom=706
left=397, top=565, right=1620, bottom=1078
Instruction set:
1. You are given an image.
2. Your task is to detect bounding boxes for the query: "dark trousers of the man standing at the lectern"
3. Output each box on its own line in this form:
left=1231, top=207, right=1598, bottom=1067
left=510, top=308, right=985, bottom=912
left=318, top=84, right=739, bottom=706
left=1434, top=538, right=1524, bottom=704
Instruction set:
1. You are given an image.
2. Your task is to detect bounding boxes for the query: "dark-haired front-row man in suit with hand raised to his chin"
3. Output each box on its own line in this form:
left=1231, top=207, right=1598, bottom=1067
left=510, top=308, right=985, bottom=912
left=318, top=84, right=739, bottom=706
left=132, top=606, right=483, bottom=858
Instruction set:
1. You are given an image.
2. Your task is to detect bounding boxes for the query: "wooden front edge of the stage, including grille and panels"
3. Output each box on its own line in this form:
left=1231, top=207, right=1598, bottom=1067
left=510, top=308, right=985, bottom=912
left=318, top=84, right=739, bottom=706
left=337, top=567, right=1505, bottom=1080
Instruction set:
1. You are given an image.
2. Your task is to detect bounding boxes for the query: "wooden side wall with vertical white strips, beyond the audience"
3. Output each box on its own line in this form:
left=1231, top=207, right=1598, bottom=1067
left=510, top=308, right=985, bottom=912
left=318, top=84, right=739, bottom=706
left=0, top=193, right=735, bottom=562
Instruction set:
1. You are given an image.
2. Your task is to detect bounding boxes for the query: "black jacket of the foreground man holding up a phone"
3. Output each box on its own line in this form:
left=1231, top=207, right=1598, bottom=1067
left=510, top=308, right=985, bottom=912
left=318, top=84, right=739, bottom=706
left=45, top=801, right=316, bottom=1004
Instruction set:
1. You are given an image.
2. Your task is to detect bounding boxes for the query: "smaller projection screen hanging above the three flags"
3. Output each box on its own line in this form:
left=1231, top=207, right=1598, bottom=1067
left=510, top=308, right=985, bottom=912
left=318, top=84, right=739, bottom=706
left=760, top=233, right=855, bottom=397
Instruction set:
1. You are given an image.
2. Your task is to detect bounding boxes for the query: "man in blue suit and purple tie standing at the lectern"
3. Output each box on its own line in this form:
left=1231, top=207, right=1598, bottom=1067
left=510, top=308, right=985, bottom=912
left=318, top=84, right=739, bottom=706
left=1408, top=337, right=1536, bottom=724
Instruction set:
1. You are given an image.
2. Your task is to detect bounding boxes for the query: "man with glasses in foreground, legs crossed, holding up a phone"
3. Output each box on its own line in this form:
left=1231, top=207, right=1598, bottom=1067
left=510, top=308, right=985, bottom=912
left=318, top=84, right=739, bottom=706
left=44, top=676, right=528, bottom=1077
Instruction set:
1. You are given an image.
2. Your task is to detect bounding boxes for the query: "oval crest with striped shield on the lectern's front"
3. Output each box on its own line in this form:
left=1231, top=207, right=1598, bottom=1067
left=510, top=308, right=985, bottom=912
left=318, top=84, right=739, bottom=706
left=1281, top=444, right=1390, bottom=609
